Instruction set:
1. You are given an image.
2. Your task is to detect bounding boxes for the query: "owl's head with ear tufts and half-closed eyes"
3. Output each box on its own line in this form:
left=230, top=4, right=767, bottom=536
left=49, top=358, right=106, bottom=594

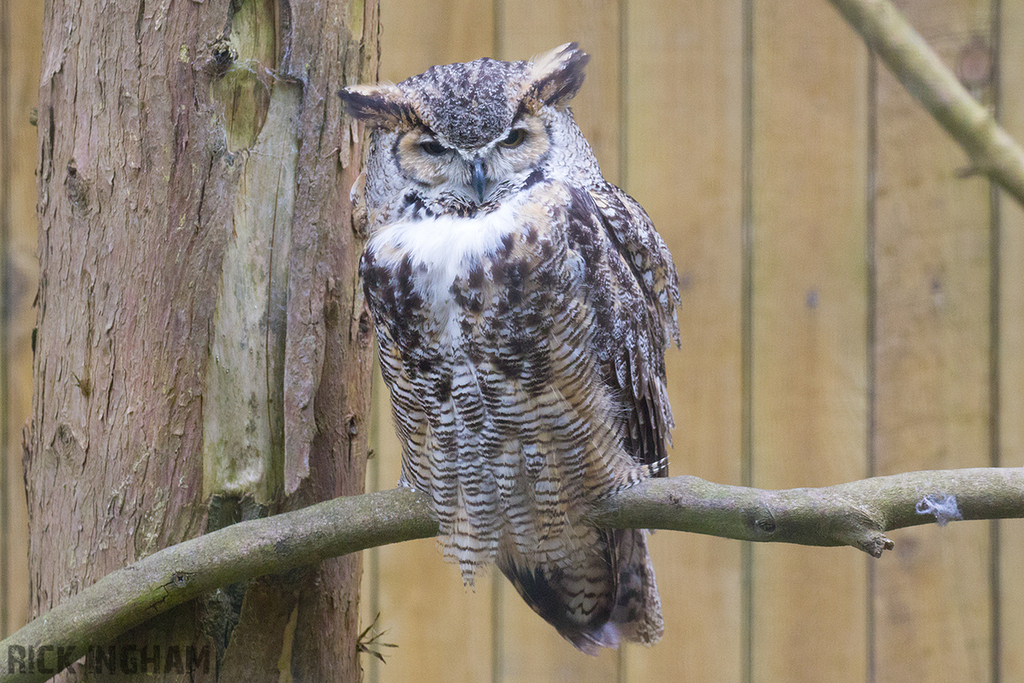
left=339, top=43, right=600, bottom=222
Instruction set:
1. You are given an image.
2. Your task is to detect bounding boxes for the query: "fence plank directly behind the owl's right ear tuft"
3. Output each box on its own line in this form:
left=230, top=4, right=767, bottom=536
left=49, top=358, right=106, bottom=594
left=496, top=0, right=621, bottom=683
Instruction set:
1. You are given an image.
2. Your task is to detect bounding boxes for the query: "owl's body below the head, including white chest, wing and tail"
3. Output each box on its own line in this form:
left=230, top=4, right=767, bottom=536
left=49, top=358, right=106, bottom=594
left=360, top=182, right=678, bottom=652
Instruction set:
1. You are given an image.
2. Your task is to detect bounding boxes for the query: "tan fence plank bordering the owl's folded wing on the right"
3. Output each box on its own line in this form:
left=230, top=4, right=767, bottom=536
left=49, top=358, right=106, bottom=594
left=624, top=0, right=742, bottom=682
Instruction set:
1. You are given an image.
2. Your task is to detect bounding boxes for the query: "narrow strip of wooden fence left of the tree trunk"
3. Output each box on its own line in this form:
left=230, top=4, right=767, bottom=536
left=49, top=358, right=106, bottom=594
left=0, top=0, right=43, bottom=635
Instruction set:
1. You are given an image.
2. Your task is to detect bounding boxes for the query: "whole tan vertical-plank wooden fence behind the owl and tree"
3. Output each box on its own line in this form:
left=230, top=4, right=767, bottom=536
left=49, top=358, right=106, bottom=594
left=0, top=0, right=1024, bottom=683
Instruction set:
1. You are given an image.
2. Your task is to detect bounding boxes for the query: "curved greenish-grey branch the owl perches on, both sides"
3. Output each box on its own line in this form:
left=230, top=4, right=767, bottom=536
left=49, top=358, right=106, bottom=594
left=0, top=468, right=1024, bottom=682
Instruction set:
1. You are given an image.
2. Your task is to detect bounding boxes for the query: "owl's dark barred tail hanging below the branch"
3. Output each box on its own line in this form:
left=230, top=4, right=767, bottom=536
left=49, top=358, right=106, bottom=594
left=498, top=529, right=663, bottom=655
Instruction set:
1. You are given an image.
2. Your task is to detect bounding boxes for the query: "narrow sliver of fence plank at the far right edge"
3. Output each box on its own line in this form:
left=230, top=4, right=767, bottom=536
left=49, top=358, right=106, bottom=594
left=996, top=2, right=1024, bottom=681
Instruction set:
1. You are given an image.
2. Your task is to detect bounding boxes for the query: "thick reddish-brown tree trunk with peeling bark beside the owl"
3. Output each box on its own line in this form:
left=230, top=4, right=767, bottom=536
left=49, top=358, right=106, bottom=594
left=25, top=0, right=378, bottom=683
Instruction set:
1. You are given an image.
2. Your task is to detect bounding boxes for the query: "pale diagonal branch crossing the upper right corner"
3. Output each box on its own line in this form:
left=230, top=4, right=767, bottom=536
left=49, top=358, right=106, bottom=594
left=829, top=0, right=1024, bottom=206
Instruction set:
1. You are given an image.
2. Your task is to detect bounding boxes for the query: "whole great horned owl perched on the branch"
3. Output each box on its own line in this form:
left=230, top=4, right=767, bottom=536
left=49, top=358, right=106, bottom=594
left=340, top=44, right=679, bottom=654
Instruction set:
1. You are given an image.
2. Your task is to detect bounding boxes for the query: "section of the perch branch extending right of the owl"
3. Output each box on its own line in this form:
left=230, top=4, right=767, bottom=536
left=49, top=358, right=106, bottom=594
left=593, top=468, right=1024, bottom=557
